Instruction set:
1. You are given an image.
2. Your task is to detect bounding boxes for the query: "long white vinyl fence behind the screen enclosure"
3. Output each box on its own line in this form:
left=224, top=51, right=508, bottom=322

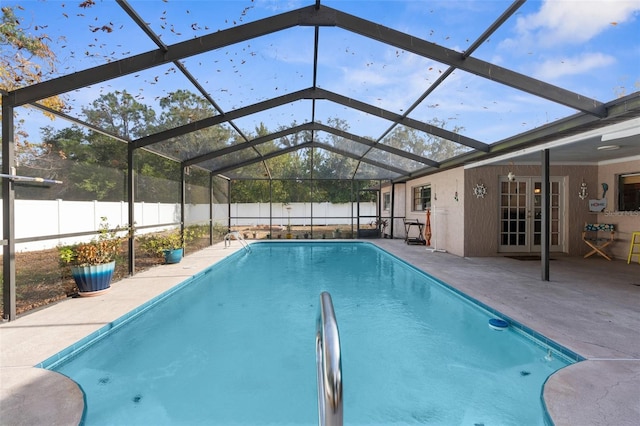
left=0, top=200, right=375, bottom=251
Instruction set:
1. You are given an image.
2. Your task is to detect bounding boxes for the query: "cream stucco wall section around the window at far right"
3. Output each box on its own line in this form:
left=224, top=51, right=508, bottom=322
left=590, top=158, right=640, bottom=261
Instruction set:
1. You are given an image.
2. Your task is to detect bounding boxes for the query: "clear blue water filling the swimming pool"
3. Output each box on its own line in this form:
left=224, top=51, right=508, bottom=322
left=45, top=242, right=571, bottom=426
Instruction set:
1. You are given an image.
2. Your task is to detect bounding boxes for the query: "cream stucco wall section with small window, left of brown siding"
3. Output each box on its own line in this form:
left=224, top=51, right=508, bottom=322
left=405, top=167, right=465, bottom=256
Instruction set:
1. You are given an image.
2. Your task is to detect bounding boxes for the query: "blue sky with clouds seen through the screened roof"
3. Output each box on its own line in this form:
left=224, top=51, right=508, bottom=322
left=8, top=0, right=640, bottom=151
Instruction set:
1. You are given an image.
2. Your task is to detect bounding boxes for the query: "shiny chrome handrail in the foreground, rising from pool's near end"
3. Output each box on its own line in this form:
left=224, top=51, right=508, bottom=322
left=316, top=291, right=342, bottom=426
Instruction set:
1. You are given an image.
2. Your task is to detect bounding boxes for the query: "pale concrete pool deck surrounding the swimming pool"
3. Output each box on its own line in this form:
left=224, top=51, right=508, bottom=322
left=0, top=240, right=640, bottom=426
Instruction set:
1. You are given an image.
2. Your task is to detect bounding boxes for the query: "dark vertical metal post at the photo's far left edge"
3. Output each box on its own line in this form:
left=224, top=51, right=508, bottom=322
left=2, top=94, right=16, bottom=321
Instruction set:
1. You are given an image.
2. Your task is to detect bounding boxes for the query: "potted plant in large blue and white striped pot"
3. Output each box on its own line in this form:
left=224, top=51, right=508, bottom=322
left=58, top=217, right=127, bottom=296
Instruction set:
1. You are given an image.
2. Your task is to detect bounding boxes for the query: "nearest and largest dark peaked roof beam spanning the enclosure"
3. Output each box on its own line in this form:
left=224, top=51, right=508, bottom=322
left=10, top=5, right=607, bottom=117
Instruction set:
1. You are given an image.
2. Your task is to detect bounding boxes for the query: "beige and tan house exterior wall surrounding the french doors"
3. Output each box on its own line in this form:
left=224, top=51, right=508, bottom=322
left=395, top=158, right=640, bottom=259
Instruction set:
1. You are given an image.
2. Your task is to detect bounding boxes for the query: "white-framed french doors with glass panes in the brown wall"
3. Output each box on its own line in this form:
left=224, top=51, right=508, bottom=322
left=498, top=176, right=564, bottom=253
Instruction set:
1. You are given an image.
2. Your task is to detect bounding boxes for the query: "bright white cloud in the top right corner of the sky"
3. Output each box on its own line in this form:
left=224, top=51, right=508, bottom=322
left=512, top=0, right=640, bottom=46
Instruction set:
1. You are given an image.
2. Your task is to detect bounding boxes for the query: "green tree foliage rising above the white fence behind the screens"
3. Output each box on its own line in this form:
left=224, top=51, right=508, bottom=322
left=11, top=83, right=456, bottom=203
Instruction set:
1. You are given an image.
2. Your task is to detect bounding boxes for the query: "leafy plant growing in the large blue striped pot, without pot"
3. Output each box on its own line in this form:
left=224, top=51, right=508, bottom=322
left=58, top=217, right=127, bottom=266
